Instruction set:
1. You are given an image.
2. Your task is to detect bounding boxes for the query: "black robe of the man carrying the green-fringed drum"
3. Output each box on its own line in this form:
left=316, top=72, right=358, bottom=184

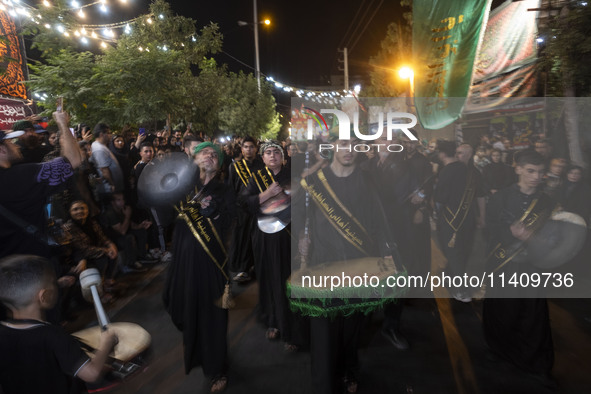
left=292, top=167, right=394, bottom=394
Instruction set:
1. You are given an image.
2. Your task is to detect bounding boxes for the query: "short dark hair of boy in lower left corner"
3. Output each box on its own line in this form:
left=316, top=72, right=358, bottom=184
left=0, top=254, right=55, bottom=310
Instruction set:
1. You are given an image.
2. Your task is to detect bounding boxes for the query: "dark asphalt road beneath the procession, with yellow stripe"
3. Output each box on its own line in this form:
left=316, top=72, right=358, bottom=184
left=68, top=237, right=591, bottom=394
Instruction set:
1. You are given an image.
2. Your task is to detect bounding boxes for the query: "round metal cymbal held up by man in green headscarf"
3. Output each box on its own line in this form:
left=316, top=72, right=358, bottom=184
left=137, top=152, right=198, bottom=207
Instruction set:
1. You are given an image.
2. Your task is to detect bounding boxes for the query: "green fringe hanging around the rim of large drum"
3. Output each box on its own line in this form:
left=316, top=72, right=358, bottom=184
left=287, top=272, right=408, bottom=319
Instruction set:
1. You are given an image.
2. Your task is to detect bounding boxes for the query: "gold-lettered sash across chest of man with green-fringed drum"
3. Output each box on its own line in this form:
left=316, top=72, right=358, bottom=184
left=300, top=170, right=371, bottom=256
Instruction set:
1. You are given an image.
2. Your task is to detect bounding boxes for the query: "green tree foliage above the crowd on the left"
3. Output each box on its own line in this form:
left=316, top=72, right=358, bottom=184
left=28, top=0, right=279, bottom=136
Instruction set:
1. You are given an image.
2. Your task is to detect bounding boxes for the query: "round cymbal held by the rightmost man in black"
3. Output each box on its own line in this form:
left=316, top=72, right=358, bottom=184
left=527, top=212, right=587, bottom=269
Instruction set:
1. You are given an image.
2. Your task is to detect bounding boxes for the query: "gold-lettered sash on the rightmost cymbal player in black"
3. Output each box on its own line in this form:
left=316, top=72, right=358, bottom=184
left=487, top=196, right=556, bottom=272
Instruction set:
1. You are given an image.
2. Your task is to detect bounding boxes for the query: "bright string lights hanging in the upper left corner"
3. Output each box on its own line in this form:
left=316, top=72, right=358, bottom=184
left=0, top=0, right=145, bottom=48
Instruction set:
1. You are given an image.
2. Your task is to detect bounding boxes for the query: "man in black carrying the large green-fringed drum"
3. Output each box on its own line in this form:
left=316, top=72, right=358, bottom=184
left=293, top=140, right=394, bottom=394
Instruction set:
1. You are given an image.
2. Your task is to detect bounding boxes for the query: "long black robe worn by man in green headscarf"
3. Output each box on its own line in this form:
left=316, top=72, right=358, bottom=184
left=162, top=180, right=234, bottom=378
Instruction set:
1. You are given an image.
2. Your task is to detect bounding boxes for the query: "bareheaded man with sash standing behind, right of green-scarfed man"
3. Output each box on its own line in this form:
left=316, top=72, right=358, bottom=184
left=228, top=137, right=264, bottom=283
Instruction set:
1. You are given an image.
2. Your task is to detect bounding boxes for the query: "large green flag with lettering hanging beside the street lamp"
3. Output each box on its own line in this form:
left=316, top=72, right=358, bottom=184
left=412, top=0, right=491, bottom=129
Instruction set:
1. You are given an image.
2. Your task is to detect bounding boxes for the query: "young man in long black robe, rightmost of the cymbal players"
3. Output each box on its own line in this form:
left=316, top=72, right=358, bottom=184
left=482, top=151, right=555, bottom=385
